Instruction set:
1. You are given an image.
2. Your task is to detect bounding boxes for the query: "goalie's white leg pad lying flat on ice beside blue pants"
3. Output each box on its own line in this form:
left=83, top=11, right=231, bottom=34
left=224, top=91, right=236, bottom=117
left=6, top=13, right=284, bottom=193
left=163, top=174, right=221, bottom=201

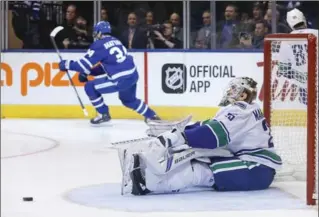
left=145, top=161, right=214, bottom=193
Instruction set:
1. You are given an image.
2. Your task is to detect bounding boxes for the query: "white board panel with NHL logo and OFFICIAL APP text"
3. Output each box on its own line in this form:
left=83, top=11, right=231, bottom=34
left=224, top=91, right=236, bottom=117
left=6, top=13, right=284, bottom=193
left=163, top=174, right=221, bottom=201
left=148, top=52, right=263, bottom=107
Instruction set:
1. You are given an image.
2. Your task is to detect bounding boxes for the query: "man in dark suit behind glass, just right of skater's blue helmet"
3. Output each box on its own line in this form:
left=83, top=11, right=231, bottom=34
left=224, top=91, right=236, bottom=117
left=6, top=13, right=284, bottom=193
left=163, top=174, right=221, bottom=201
left=120, top=13, right=147, bottom=49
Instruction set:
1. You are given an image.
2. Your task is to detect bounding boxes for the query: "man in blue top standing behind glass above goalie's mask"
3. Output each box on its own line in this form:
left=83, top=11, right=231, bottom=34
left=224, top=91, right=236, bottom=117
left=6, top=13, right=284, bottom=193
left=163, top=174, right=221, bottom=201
left=217, top=5, right=241, bottom=48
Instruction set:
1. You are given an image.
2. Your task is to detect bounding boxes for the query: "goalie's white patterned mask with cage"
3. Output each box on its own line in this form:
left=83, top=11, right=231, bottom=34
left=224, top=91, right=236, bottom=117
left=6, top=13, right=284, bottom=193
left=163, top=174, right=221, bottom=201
left=219, top=77, right=257, bottom=106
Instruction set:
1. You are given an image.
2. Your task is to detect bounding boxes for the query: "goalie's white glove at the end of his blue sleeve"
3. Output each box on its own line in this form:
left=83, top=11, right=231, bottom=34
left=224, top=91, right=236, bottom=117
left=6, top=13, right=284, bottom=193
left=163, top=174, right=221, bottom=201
left=157, top=128, right=190, bottom=152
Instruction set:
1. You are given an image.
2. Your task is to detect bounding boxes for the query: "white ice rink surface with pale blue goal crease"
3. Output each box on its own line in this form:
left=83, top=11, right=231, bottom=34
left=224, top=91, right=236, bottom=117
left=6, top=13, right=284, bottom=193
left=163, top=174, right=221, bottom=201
left=1, top=119, right=318, bottom=217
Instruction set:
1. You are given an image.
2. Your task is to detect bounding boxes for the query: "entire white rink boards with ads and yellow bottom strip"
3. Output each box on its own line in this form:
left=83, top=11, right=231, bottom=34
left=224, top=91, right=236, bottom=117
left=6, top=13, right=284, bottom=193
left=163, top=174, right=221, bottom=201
left=0, top=51, right=307, bottom=118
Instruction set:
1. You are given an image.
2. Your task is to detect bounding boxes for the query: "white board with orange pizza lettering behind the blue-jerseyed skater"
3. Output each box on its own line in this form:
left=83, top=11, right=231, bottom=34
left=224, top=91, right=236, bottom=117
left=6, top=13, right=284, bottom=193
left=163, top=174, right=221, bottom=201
left=1, top=53, right=144, bottom=105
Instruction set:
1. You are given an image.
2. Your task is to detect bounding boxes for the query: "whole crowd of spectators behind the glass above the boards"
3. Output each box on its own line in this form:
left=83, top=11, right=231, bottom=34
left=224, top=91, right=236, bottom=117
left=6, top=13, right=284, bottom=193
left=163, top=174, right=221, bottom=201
left=10, top=1, right=319, bottom=49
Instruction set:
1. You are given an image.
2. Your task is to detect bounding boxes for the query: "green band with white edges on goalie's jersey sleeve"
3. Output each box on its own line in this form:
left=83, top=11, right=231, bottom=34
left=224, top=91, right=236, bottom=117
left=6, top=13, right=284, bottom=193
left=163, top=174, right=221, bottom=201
left=205, top=120, right=230, bottom=147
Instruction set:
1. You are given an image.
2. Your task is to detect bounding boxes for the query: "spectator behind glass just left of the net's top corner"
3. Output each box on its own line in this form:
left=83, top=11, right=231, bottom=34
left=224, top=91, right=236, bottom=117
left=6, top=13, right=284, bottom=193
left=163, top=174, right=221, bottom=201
left=240, top=21, right=268, bottom=49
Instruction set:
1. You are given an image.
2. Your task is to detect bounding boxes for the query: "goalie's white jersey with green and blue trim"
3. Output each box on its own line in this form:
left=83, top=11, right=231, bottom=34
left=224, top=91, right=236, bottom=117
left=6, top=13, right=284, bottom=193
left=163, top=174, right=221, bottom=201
left=201, top=101, right=282, bottom=169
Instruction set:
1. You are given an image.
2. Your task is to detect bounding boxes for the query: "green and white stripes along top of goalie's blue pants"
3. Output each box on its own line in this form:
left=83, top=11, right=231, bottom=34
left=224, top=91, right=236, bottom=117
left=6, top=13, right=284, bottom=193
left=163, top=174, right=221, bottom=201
left=210, top=159, right=260, bottom=174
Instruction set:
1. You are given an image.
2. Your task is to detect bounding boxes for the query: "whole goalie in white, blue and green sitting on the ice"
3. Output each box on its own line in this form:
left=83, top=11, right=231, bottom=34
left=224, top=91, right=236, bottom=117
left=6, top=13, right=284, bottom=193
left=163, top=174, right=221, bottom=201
left=122, top=77, right=282, bottom=195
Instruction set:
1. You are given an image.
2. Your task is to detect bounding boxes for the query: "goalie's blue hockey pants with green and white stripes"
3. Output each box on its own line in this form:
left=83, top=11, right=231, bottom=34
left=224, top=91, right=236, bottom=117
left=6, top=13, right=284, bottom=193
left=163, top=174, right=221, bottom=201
left=210, top=157, right=275, bottom=191
